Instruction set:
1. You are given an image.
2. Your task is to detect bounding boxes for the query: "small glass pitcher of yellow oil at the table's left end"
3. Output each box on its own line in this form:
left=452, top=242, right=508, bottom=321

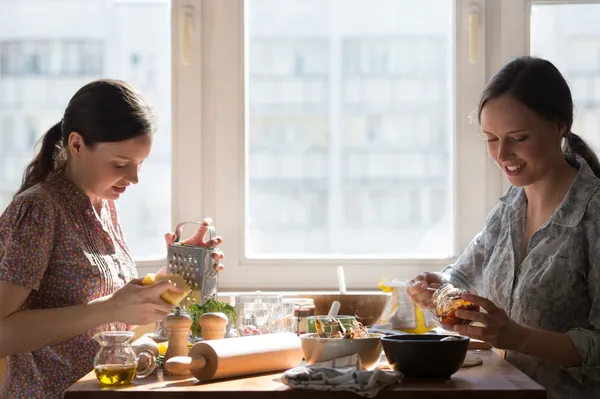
left=93, top=331, right=156, bottom=386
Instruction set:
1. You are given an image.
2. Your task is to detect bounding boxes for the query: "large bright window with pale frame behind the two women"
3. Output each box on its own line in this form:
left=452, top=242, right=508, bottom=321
left=9, top=0, right=600, bottom=291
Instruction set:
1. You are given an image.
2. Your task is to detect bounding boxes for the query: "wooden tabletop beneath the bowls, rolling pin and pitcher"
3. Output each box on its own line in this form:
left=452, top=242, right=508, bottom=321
left=64, top=350, right=546, bottom=399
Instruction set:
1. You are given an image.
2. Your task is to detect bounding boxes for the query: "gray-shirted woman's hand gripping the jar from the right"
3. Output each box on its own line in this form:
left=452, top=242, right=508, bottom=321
left=454, top=294, right=524, bottom=349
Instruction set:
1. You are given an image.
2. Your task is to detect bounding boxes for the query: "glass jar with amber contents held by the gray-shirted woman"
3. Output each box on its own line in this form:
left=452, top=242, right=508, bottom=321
left=431, top=283, right=479, bottom=331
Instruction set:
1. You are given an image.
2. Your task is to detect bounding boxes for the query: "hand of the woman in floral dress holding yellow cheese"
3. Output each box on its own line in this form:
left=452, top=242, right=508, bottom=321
left=106, top=279, right=183, bottom=325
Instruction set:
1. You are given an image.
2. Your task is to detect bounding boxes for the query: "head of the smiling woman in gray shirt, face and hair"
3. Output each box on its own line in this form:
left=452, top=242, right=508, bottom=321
left=479, top=57, right=600, bottom=186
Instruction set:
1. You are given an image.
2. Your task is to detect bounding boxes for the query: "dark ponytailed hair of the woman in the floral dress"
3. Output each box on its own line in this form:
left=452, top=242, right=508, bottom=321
left=16, top=79, right=155, bottom=195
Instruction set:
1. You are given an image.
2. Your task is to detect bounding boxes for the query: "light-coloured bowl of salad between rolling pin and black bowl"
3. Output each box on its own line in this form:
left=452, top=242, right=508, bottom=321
left=300, top=333, right=384, bottom=370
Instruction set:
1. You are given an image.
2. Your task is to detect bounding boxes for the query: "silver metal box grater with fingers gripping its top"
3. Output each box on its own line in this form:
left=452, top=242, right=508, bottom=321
left=167, top=218, right=224, bottom=310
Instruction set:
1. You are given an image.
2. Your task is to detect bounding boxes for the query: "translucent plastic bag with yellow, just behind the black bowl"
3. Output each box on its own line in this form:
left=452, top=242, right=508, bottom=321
left=375, top=278, right=437, bottom=334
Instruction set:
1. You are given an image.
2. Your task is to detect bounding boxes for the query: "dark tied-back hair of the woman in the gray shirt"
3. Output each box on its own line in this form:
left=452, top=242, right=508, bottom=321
left=477, top=56, right=600, bottom=177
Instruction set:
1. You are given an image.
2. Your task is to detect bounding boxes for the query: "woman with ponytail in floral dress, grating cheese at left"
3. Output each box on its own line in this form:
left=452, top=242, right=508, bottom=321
left=0, top=80, right=185, bottom=399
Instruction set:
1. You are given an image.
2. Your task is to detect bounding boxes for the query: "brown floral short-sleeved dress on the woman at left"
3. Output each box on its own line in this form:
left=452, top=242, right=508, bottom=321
left=0, top=174, right=137, bottom=399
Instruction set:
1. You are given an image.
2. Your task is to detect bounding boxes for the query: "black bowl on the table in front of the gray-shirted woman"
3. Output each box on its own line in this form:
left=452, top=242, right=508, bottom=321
left=381, top=334, right=469, bottom=380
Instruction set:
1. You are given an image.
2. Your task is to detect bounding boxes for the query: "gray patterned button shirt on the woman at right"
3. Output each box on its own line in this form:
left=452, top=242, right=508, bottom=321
left=442, top=157, right=600, bottom=399
